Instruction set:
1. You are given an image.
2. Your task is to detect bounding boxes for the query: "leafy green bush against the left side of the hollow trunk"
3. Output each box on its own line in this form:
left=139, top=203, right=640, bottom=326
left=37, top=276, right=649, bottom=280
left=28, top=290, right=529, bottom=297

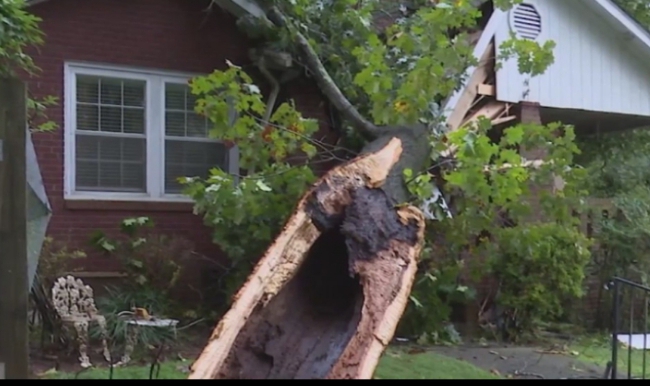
left=185, top=164, right=315, bottom=302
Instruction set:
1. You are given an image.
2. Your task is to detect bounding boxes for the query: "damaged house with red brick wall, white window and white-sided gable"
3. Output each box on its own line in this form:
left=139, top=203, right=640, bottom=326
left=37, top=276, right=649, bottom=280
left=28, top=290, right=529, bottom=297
left=29, top=0, right=650, bottom=324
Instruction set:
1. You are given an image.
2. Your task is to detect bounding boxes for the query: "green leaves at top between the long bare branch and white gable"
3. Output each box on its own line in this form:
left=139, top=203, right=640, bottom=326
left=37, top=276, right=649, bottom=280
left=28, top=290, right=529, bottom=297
left=263, top=0, right=553, bottom=130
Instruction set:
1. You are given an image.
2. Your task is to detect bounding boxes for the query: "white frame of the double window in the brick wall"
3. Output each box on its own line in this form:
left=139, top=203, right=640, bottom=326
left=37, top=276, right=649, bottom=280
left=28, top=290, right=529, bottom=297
left=63, top=62, right=239, bottom=202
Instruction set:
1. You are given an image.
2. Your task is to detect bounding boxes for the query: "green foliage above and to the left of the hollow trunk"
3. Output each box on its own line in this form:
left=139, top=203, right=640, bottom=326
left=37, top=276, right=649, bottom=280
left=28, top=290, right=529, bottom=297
left=184, top=0, right=553, bottom=320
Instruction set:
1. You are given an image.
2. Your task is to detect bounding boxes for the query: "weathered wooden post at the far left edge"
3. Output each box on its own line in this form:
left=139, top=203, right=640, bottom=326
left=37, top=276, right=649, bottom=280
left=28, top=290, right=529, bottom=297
left=0, top=78, right=29, bottom=379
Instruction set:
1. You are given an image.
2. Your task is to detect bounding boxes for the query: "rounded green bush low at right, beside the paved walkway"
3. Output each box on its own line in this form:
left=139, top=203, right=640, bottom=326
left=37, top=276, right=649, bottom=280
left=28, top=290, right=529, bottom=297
left=489, top=223, right=591, bottom=338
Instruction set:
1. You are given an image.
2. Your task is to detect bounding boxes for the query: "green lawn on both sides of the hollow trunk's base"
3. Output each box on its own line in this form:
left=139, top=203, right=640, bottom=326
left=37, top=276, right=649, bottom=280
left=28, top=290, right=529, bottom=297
left=42, top=349, right=498, bottom=379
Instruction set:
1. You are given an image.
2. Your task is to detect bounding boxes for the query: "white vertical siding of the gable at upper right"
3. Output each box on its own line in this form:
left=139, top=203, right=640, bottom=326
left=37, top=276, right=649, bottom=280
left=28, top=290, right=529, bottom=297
left=495, top=0, right=650, bottom=116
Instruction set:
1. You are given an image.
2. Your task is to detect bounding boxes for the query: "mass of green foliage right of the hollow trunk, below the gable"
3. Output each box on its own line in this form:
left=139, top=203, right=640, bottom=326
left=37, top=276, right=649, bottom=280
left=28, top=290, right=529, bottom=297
left=403, top=120, right=589, bottom=340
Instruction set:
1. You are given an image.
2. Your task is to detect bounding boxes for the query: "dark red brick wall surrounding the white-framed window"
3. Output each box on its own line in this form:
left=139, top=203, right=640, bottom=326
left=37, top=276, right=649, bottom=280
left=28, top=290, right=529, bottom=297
left=28, top=0, right=325, bottom=270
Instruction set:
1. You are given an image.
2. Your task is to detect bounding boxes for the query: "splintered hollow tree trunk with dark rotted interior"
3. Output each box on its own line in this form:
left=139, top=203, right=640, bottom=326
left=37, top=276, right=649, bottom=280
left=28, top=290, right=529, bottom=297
left=189, top=135, right=424, bottom=379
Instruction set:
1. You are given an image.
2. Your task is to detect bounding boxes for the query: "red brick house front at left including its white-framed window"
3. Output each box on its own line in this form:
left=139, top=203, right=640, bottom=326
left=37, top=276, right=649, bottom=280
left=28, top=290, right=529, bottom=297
left=27, top=0, right=328, bottom=276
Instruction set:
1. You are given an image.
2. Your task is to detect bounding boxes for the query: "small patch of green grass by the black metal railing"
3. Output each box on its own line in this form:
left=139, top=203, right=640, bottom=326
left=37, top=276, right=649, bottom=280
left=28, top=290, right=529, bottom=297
left=571, top=336, right=650, bottom=377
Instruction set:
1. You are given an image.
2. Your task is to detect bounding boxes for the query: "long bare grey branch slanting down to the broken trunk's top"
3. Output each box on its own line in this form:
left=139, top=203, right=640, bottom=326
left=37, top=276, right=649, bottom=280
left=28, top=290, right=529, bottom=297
left=266, top=7, right=381, bottom=140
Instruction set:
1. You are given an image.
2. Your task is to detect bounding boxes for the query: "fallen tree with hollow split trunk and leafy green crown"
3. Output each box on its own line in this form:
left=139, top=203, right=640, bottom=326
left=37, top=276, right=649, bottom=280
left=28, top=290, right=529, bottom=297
left=190, top=0, right=556, bottom=379
